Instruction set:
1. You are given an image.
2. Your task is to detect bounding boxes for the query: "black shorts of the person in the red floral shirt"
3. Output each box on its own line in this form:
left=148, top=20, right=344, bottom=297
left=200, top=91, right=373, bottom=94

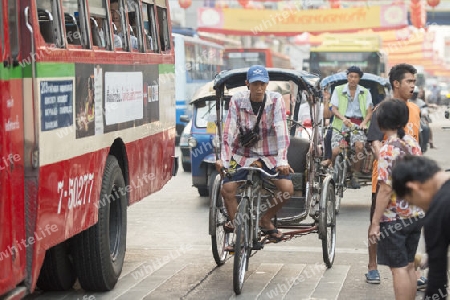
left=377, top=216, right=424, bottom=268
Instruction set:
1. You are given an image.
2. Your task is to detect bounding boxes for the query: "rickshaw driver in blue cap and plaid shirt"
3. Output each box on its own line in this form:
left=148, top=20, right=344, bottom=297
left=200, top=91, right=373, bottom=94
left=216, top=65, right=294, bottom=241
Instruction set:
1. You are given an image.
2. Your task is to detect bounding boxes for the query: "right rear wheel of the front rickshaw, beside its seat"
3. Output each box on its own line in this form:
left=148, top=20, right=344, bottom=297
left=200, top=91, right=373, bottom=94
left=319, top=177, right=336, bottom=268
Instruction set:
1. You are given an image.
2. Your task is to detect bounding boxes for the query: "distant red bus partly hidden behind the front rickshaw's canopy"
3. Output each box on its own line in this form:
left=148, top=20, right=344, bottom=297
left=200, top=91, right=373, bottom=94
left=223, top=48, right=292, bottom=70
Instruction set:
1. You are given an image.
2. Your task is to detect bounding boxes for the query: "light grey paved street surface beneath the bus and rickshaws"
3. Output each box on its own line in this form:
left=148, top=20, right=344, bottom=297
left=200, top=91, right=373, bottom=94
left=27, top=108, right=450, bottom=300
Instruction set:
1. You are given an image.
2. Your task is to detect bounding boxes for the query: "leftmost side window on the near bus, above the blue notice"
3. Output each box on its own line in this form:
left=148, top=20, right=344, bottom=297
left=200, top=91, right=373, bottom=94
left=36, top=0, right=64, bottom=48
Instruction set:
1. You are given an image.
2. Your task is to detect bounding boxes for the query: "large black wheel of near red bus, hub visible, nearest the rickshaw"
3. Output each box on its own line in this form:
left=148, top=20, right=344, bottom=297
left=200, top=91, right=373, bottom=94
left=73, top=155, right=127, bottom=292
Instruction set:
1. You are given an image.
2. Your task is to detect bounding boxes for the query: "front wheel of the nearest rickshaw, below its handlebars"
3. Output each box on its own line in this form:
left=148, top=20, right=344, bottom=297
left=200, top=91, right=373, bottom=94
left=233, top=197, right=251, bottom=295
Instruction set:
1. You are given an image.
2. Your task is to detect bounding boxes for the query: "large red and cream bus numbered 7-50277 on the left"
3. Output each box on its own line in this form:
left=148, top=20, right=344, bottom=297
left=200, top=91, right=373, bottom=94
left=0, top=0, right=178, bottom=299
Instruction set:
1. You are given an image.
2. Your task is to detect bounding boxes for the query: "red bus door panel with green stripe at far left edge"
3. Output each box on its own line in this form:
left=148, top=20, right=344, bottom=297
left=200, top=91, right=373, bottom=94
left=0, top=0, right=29, bottom=295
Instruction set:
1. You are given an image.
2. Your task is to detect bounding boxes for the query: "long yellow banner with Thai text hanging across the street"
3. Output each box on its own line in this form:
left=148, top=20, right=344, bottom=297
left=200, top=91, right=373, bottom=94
left=197, top=5, right=407, bottom=36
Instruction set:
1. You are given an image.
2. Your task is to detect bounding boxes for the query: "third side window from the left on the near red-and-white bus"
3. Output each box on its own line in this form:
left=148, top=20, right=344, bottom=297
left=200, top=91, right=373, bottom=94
left=89, top=0, right=112, bottom=50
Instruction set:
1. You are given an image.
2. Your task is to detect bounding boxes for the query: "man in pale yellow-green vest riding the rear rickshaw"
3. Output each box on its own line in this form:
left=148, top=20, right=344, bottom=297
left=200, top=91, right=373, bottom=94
left=331, top=66, right=372, bottom=189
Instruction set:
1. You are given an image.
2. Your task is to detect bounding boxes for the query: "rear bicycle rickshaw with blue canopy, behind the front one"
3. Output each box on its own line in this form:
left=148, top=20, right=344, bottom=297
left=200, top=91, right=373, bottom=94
left=320, top=72, right=391, bottom=213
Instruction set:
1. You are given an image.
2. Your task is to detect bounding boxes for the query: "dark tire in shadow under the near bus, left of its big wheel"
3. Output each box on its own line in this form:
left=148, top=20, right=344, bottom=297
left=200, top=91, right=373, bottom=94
left=36, top=242, right=77, bottom=291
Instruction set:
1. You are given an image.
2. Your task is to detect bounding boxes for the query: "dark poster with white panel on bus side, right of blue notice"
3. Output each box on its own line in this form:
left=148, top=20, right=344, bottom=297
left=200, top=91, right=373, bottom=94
left=75, top=64, right=160, bottom=138
